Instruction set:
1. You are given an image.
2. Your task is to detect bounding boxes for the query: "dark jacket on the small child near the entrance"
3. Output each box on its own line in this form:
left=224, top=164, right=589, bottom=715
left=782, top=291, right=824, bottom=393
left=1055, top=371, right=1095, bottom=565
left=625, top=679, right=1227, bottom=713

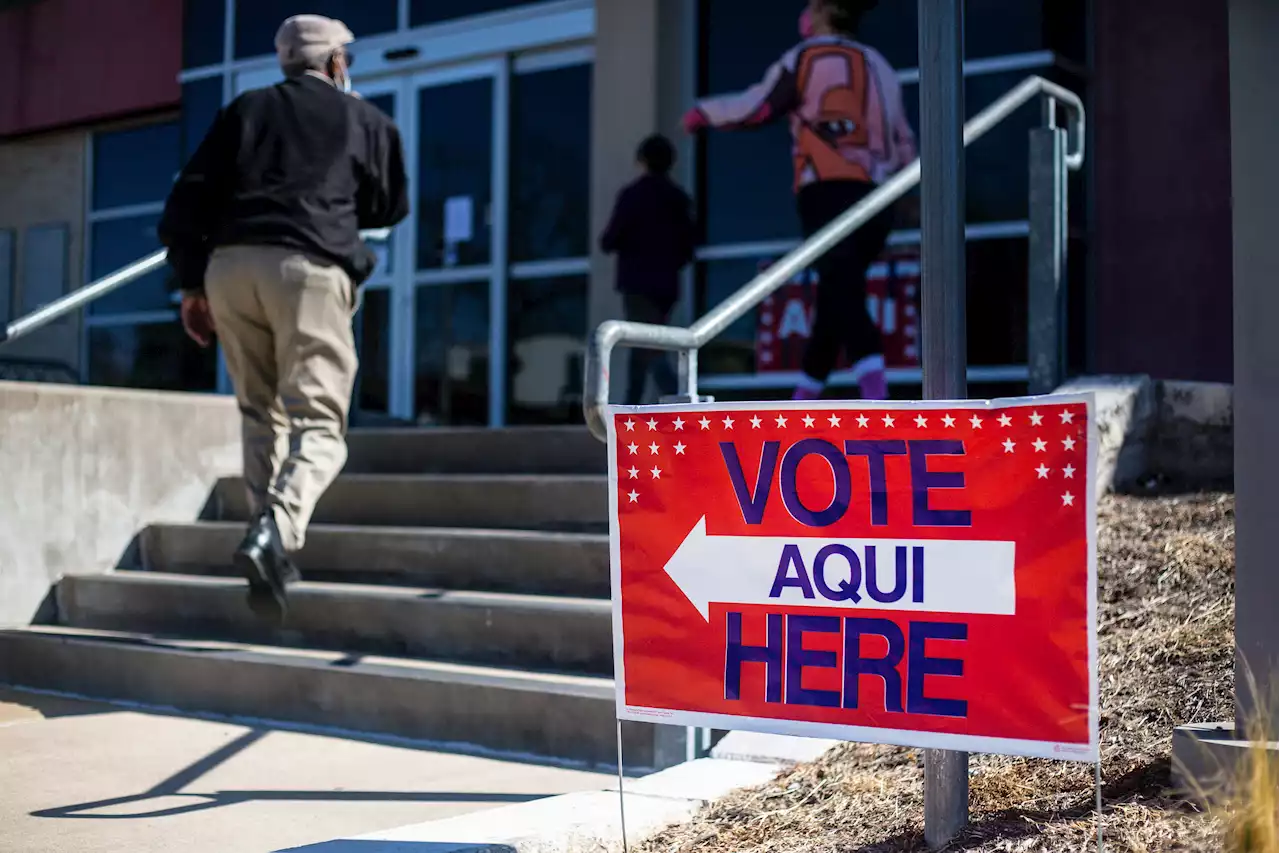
left=600, top=174, right=696, bottom=310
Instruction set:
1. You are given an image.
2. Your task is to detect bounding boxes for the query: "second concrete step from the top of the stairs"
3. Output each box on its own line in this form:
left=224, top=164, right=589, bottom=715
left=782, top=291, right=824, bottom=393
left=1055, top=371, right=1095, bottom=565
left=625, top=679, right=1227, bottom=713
left=215, top=474, right=609, bottom=533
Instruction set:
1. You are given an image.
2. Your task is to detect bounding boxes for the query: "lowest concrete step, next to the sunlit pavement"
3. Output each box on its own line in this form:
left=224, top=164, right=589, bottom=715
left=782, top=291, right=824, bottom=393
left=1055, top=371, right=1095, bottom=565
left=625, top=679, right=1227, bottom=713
left=0, top=628, right=660, bottom=767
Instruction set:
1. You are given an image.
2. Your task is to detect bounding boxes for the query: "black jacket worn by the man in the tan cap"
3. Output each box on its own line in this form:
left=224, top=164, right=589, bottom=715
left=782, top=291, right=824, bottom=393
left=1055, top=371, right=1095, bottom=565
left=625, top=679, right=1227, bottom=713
left=159, top=74, right=408, bottom=291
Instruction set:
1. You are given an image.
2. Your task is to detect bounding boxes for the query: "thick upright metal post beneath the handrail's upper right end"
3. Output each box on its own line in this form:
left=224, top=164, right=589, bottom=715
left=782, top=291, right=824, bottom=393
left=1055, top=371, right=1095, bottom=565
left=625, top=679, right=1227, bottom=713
left=1027, top=115, right=1068, bottom=394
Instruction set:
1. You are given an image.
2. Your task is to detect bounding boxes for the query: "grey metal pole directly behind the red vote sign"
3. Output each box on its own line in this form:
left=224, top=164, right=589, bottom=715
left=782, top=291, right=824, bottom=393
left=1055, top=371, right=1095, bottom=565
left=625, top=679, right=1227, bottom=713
left=919, top=0, right=969, bottom=849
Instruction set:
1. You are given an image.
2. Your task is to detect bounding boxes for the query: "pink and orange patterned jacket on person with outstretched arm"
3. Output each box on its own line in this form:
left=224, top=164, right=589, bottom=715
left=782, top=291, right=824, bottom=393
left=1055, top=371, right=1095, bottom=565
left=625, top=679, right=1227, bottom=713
left=696, top=36, right=915, bottom=190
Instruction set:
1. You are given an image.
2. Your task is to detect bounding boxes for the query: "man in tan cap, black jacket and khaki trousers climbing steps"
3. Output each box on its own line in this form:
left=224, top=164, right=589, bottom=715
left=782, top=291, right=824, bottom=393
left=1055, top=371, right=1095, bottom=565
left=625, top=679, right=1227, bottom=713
left=160, top=15, right=408, bottom=613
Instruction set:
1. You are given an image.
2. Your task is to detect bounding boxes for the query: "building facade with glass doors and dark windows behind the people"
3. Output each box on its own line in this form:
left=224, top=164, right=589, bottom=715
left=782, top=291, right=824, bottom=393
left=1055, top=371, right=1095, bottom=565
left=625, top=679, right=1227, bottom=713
left=0, top=0, right=1231, bottom=425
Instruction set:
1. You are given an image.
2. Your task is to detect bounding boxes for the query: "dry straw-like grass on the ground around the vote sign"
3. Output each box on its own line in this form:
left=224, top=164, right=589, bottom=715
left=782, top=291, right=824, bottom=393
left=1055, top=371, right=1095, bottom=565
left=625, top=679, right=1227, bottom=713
left=641, top=493, right=1235, bottom=853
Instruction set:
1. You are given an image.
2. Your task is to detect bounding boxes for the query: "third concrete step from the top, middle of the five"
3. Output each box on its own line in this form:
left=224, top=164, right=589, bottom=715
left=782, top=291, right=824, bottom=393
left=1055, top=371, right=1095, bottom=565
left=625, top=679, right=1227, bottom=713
left=141, top=521, right=609, bottom=598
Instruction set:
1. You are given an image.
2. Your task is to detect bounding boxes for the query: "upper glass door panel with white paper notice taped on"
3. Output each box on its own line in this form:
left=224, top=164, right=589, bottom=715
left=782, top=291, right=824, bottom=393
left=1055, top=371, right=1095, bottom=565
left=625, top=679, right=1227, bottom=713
left=416, top=77, right=493, bottom=269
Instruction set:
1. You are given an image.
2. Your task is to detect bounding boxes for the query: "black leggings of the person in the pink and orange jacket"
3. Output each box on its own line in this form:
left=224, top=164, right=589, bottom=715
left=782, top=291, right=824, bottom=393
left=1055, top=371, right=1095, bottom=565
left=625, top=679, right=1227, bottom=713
left=796, top=181, right=893, bottom=382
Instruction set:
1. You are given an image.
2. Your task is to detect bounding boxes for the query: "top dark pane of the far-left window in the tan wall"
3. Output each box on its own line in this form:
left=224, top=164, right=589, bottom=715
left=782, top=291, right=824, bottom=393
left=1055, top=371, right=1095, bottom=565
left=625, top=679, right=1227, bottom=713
left=93, top=122, right=182, bottom=210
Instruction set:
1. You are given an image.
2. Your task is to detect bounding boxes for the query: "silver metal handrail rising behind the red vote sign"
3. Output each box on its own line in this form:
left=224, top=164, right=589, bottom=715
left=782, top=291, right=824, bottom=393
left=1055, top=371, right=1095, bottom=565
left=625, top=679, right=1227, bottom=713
left=582, top=77, right=1084, bottom=442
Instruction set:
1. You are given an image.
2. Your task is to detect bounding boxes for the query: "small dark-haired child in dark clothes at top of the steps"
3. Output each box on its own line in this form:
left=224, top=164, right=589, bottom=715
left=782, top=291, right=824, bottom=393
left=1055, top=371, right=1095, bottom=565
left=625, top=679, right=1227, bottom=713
left=600, top=134, right=695, bottom=406
